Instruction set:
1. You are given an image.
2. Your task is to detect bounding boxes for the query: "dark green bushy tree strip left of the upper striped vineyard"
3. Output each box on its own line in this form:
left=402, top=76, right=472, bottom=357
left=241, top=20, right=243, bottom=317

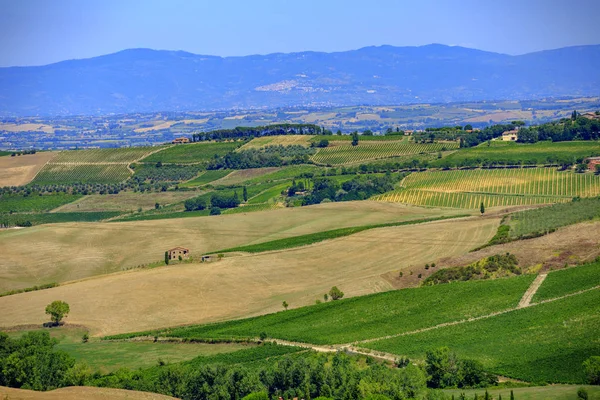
left=207, top=145, right=315, bottom=169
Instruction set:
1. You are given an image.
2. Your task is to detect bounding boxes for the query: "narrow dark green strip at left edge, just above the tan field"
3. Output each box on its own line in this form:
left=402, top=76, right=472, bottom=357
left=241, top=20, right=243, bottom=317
left=0, top=211, right=121, bottom=226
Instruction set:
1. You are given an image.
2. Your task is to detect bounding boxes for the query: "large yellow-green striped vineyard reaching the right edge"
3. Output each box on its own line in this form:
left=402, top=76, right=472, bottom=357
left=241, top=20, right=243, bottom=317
left=375, top=168, right=600, bottom=208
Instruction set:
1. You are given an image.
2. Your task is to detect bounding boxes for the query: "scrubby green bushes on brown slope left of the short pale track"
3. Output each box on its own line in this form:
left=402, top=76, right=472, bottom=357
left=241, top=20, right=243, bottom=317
left=422, top=253, right=521, bottom=286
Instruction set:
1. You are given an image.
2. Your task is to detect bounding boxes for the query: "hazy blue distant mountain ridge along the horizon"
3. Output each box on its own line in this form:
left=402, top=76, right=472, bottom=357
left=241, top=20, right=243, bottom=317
left=0, top=44, right=600, bottom=116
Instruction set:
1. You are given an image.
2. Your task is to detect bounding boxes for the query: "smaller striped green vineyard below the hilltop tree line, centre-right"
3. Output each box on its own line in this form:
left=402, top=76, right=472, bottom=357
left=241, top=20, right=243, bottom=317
left=312, top=139, right=458, bottom=165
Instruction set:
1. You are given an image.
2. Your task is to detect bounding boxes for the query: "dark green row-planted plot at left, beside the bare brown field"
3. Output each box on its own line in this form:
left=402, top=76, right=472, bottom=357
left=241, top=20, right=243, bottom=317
left=32, top=164, right=131, bottom=185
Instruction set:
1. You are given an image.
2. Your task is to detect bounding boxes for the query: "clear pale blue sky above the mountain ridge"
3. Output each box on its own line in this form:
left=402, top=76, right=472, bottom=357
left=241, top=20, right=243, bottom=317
left=0, top=0, right=600, bottom=67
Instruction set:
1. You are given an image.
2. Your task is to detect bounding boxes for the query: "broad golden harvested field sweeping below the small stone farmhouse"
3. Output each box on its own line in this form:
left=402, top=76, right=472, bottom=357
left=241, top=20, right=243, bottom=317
left=0, top=211, right=500, bottom=335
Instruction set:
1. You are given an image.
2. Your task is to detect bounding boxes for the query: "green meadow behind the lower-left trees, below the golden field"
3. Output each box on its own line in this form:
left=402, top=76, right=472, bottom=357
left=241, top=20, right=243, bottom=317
left=3, top=327, right=254, bottom=373
